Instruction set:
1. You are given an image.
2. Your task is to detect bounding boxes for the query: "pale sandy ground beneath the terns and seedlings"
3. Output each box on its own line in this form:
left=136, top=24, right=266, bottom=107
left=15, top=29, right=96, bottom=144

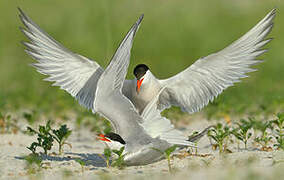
left=0, top=120, right=284, bottom=180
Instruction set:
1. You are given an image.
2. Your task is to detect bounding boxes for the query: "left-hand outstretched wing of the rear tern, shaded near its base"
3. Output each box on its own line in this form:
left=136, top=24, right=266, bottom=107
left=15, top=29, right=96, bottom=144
left=19, top=9, right=103, bottom=111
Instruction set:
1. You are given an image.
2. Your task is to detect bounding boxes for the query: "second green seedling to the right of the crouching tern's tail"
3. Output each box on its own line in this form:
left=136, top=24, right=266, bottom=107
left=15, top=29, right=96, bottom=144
left=232, top=119, right=253, bottom=149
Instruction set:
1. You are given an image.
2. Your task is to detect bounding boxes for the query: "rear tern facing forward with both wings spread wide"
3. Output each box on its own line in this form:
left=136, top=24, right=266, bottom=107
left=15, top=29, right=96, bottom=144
left=19, top=9, right=276, bottom=114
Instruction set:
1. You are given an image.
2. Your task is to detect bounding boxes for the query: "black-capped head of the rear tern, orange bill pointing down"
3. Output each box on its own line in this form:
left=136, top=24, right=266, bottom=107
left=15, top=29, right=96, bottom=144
left=133, top=64, right=151, bottom=93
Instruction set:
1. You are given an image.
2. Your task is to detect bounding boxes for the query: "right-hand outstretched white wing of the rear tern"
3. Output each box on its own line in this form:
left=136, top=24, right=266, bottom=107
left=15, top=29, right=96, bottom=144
left=159, top=9, right=276, bottom=113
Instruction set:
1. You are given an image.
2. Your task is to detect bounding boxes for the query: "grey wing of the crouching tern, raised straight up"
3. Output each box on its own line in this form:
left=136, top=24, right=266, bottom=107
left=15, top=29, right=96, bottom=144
left=94, top=15, right=146, bottom=142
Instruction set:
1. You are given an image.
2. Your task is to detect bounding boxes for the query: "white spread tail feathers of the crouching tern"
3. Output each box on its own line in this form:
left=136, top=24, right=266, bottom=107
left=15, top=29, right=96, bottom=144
left=141, top=89, right=195, bottom=146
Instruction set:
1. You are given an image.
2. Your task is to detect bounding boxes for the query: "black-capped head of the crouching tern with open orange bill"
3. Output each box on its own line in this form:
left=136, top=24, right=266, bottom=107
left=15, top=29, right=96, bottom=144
left=98, top=132, right=126, bottom=150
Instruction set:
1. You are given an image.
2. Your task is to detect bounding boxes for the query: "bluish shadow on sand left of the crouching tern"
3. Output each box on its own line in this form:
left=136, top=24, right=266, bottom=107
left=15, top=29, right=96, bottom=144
left=15, top=153, right=107, bottom=167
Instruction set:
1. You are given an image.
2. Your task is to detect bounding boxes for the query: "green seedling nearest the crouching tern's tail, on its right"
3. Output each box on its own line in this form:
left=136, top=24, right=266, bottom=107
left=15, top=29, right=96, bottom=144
left=207, top=123, right=231, bottom=154
